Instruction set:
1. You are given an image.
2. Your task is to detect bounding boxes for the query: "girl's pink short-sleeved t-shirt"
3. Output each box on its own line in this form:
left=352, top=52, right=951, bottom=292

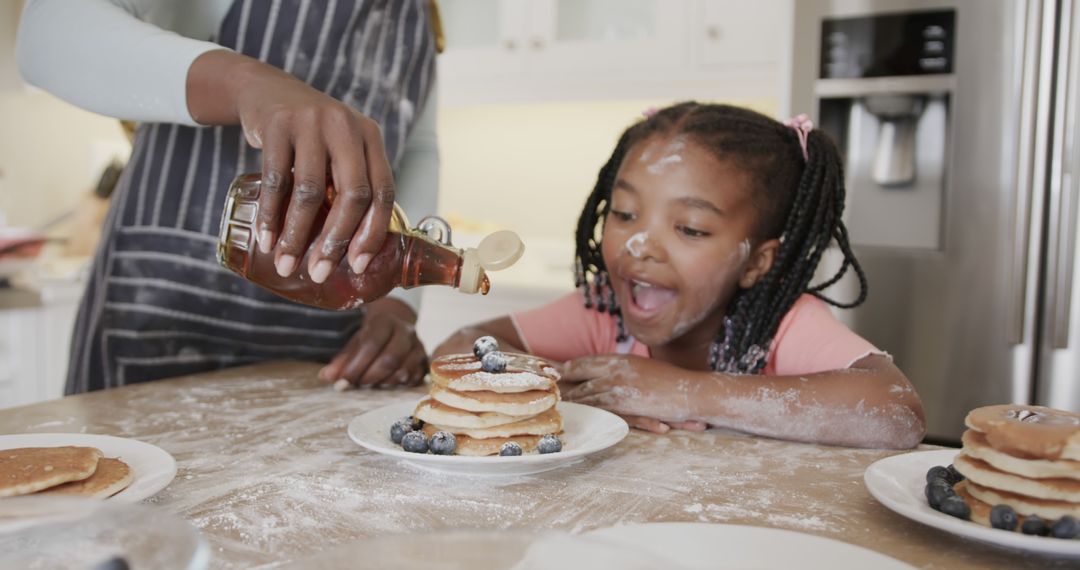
left=511, top=291, right=887, bottom=376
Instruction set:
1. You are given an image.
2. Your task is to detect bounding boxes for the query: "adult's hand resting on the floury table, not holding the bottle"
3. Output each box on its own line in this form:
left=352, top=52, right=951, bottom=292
left=319, top=297, right=428, bottom=388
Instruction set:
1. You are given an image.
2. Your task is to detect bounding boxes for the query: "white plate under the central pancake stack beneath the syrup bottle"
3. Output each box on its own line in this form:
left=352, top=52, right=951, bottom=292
left=349, top=402, right=630, bottom=476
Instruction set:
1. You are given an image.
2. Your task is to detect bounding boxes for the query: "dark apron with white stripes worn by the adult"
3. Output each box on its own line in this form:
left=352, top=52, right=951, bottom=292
left=66, top=0, right=435, bottom=394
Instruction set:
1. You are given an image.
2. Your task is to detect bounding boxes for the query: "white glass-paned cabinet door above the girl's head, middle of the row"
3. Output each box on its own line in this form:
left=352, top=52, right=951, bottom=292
left=527, top=0, right=688, bottom=79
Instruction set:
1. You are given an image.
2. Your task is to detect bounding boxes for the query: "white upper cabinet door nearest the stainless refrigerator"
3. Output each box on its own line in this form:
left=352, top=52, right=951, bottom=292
left=690, top=0, right=792, bottom=68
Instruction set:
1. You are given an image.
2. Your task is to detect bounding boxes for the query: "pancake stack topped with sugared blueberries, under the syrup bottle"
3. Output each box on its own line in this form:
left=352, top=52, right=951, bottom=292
left=414, top=337, right=563, bottom=456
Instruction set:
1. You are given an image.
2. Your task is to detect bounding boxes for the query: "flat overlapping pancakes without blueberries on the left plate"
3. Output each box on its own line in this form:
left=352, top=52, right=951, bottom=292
left=0, top=446, right=134, bottom=499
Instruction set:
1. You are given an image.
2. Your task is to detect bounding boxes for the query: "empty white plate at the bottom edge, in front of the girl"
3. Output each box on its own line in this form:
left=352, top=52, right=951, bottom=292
left=582, top=523, right=912, bottom=570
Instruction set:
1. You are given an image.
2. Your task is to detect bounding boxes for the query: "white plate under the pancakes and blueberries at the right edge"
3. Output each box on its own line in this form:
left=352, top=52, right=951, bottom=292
left=863, top=449, right=1080, bottom=558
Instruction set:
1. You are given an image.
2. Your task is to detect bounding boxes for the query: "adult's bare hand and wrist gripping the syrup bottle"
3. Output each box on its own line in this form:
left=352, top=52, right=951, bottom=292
left=187, top=50, right=394, bottom=283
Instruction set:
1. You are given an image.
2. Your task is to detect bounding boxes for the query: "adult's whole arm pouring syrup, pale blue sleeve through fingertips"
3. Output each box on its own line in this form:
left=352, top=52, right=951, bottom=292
left=18, top=0, right=406, bottom=283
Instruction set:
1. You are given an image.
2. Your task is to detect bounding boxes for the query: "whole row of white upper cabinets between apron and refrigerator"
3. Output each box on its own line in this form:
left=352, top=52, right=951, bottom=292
left=440, top=0, right=792, bottom=105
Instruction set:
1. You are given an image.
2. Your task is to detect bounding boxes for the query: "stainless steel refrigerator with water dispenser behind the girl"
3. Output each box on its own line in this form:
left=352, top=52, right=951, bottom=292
left=785, top=0, right=1080, bottom=442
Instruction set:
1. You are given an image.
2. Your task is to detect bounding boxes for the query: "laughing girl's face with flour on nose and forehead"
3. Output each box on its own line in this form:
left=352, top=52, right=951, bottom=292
left=602, top=135, right=779, bottom=348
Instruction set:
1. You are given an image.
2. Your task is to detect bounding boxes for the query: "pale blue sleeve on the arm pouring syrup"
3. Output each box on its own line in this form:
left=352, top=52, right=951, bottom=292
left=16, top=0, right=229, bottom=126
